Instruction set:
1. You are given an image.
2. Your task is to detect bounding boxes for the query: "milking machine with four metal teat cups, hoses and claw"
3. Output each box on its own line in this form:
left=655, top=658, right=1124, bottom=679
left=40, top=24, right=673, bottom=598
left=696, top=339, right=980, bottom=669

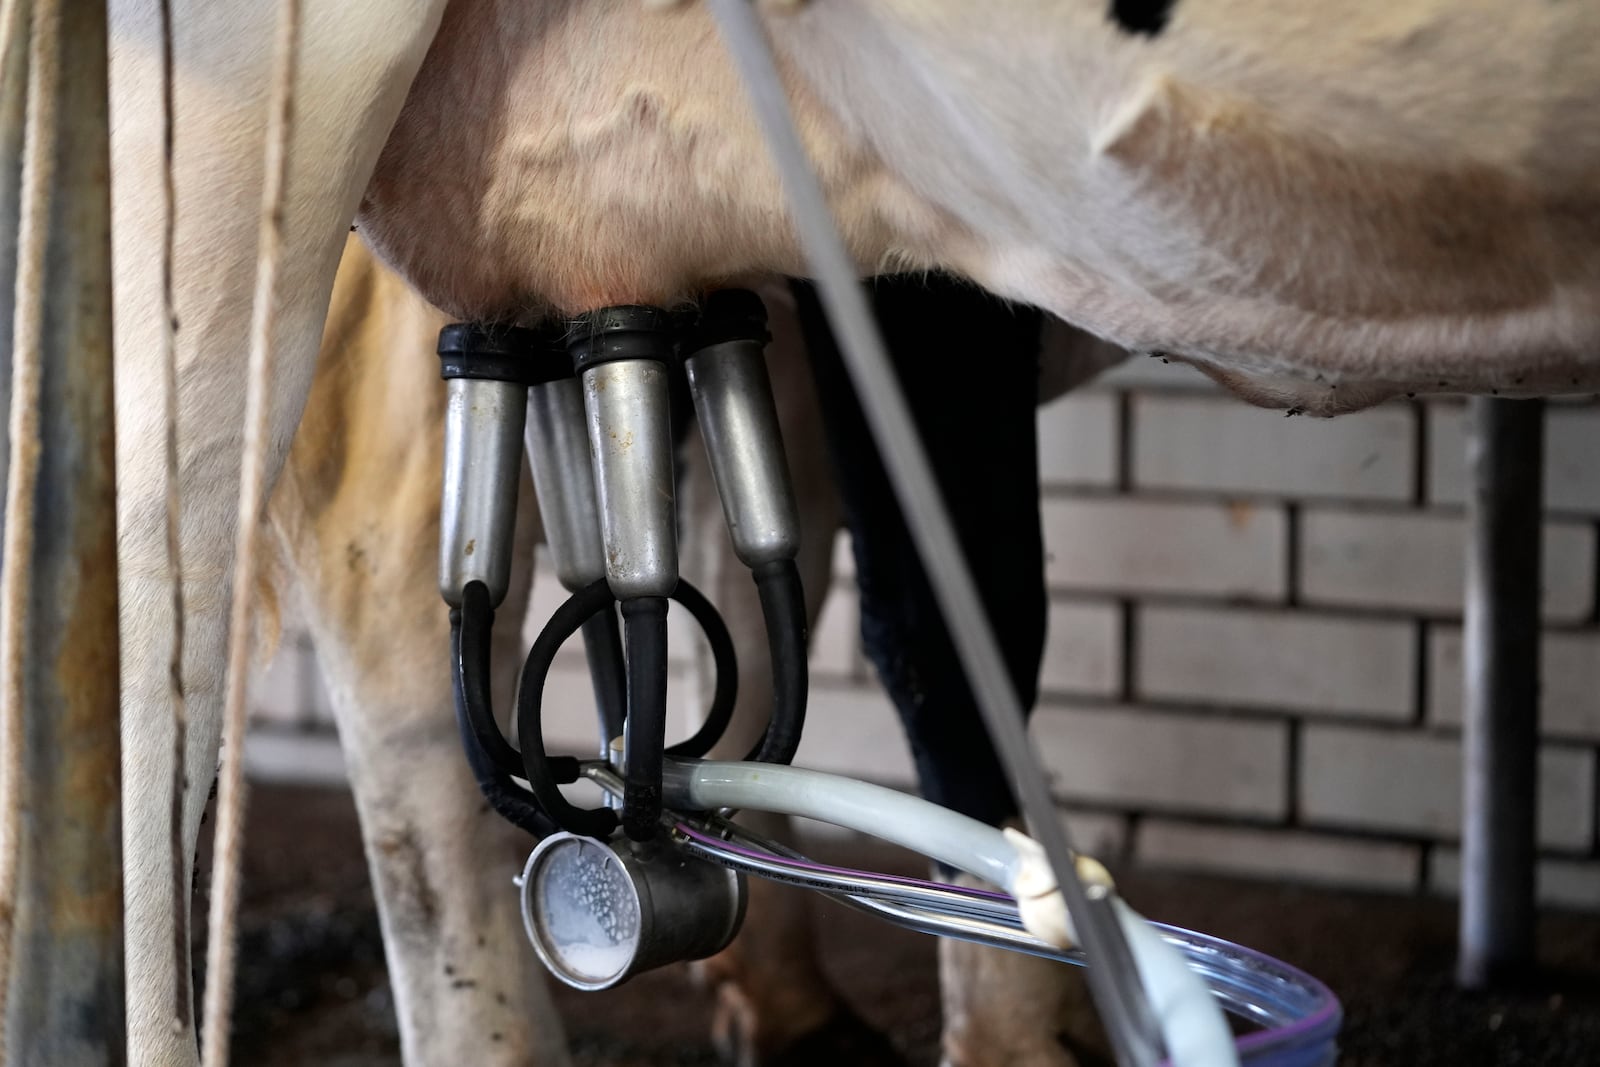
left=438, top=291, right=1339, bottom=1065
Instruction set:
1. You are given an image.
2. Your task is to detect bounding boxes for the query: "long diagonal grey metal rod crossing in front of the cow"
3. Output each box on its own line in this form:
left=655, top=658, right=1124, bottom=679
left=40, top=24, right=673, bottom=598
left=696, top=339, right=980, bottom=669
left=710, top=0, right=1165, bottom=1067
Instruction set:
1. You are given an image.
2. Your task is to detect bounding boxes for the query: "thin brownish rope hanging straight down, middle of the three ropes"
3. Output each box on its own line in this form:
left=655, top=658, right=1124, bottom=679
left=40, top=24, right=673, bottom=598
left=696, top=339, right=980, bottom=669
left=162, top=0, right=194, bottom=1033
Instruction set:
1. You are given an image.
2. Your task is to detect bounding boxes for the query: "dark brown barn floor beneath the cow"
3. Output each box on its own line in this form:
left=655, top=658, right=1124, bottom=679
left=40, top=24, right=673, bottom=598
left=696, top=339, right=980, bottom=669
left=212, top=787, right=1600, bottom=1067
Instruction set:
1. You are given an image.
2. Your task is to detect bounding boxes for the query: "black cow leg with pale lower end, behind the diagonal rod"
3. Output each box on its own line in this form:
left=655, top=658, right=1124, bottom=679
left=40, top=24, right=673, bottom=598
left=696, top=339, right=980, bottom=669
left=802, top=278, right=1100, bottom=1067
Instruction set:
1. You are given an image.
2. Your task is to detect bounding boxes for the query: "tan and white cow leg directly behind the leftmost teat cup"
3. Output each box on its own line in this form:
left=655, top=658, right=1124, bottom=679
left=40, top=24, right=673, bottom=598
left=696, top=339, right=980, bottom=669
left=272, top=240, right=566, bottom=1067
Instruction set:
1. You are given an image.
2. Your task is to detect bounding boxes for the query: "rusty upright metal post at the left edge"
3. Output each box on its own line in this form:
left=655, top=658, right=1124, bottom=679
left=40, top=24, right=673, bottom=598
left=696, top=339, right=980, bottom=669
left=5, top=0, right=126, bottom=1067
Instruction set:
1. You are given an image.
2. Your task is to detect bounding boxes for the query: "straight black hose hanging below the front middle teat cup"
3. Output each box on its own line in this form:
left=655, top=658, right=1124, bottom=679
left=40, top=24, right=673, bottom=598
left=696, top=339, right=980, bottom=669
left=622, top=597, right=667, bottom=841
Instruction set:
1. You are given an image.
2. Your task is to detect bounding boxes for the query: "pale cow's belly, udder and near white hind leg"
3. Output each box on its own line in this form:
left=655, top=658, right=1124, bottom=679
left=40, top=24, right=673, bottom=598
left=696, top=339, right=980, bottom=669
left=112, top=0, right=1600, bottom=1062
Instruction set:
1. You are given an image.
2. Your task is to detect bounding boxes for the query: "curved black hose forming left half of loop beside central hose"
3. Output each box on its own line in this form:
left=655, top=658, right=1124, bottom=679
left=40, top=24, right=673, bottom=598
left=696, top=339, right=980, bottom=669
left=517, top=577, right=616, bottom=840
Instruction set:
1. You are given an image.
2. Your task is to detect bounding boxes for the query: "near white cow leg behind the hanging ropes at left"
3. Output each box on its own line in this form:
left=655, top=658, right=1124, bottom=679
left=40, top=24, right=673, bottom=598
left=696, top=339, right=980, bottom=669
left=110, top=0, right=442, bottom=1067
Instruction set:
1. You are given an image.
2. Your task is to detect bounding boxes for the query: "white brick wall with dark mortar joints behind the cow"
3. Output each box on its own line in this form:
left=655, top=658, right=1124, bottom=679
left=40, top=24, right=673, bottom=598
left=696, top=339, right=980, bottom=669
left=251, top=388, right=1600, bottom=909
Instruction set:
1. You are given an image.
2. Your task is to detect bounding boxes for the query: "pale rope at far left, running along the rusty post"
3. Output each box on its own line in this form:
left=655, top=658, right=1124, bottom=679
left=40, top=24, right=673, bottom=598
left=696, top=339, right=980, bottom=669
left=0, top=0, right=61, bottom=1064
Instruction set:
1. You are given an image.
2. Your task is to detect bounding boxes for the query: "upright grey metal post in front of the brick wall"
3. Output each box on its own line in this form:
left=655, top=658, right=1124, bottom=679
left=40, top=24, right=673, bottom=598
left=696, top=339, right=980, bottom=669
left=1456, top=398, right=1544, bottom=987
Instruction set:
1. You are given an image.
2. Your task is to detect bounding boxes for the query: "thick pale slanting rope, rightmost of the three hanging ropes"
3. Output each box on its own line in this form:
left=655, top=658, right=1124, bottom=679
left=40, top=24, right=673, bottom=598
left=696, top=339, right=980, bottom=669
left=202, top=0, right=299, bottom=1067
